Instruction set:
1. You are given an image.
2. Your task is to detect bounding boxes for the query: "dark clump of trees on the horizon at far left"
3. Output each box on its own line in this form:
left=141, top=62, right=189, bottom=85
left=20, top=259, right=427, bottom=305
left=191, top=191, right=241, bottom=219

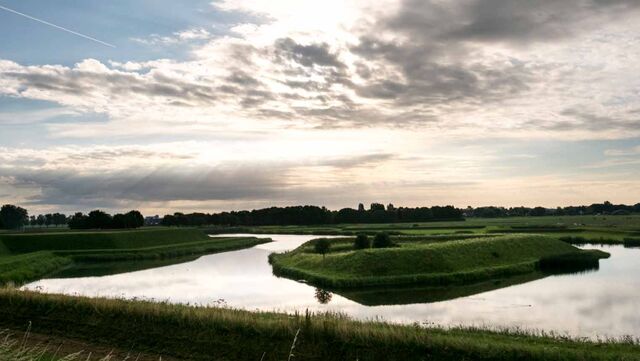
left=0, top=204, right=144, bottom=229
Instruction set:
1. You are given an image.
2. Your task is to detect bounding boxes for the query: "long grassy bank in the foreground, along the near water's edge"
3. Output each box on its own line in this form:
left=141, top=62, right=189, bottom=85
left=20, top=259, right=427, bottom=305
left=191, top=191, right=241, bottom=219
left=0, top=289, right=640, bottom=361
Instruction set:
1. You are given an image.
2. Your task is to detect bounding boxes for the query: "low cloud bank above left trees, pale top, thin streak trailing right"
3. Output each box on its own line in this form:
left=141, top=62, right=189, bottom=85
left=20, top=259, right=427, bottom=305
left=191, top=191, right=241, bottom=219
left=0, top=143, right=404, bottom=207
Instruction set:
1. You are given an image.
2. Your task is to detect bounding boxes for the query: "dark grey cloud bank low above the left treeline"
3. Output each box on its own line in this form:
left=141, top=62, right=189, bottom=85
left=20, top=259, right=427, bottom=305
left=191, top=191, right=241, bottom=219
left=0, top=167, right=286, bottom=205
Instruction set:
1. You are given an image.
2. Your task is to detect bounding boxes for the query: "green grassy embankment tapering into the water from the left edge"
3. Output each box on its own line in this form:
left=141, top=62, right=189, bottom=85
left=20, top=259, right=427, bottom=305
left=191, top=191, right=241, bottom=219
left=0, top=228, right=270, bottom=284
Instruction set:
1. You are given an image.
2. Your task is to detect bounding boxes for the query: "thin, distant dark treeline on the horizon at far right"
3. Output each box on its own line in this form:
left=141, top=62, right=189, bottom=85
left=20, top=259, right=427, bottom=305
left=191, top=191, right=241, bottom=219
left=464, top=201, right=640, bottom=218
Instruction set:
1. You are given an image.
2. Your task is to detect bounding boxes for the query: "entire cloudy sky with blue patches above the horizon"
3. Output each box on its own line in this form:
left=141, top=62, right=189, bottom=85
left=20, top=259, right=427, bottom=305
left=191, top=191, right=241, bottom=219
left=0, top=0, right=640, bottom=214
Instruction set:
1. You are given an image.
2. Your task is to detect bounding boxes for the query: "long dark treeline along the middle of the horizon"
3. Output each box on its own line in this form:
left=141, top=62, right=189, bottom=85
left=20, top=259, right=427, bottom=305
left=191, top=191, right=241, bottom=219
left=161, top=203, right=462, bottom=226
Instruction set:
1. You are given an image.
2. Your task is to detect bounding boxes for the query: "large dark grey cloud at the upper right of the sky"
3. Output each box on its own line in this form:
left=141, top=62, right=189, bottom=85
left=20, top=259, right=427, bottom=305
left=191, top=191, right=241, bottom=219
left=340, top=0, right=640, bottom=121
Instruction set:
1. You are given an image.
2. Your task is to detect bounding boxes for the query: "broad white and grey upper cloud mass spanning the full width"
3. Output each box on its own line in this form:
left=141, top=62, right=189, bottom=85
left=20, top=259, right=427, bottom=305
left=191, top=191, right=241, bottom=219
left=0, top=0, right=640, bottom=138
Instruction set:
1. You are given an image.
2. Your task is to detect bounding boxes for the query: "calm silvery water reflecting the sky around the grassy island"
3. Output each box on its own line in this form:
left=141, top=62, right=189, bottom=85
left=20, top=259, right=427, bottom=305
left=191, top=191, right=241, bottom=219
left=24, top=235, right=640, bottom=338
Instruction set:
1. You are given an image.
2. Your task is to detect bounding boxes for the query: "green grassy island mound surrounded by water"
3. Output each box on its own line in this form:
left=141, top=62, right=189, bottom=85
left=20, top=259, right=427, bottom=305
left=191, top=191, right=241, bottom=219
left=269, top=235, right=608, bottom=288
